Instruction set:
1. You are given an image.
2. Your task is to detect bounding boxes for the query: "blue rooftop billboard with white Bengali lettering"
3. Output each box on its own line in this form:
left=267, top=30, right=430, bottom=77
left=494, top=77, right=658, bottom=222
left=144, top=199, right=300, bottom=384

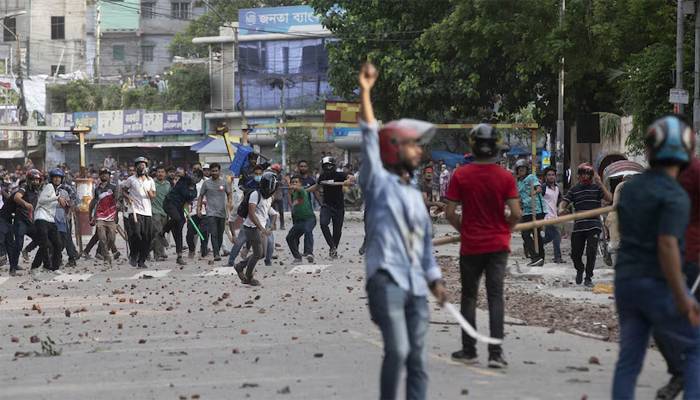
left=238, top=6, right=324, bottom=35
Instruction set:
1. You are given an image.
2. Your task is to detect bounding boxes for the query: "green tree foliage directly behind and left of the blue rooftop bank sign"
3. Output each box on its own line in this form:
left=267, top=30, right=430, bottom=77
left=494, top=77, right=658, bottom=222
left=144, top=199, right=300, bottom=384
left=168, top=0, right=303, bottom=58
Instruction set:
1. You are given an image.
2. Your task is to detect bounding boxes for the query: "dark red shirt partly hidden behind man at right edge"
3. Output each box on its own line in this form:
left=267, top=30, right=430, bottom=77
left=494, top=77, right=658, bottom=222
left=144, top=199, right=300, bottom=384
left=678, top=158, right=700, bottom=262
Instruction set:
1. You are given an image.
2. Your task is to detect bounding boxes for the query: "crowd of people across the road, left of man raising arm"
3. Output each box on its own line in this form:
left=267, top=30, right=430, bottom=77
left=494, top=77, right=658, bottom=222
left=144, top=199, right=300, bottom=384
left=0, top=154, right=355, bottom=285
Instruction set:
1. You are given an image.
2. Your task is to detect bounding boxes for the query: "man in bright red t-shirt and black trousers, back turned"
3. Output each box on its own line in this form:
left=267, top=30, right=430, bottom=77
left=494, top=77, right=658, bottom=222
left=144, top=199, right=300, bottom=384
left=446, top=124, right=522, bottom=368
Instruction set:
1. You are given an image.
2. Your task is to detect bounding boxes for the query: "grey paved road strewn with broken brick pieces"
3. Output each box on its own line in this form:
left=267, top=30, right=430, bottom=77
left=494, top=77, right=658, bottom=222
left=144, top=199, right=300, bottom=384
left=0, top=222, right=667, bottom=400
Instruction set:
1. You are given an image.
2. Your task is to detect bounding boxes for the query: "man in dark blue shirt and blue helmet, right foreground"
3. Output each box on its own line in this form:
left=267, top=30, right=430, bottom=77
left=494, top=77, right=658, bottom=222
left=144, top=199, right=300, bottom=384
left=612, top=116, right=700, bottom=400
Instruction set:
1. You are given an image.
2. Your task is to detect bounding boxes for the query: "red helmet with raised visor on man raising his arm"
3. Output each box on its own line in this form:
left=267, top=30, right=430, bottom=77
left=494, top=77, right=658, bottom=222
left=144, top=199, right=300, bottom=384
left=379, top=118, right=435, bottom=167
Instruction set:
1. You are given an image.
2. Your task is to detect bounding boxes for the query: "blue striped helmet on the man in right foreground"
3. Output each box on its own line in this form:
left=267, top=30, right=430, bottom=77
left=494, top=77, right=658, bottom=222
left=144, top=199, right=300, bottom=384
left=644, top=115, right=695, bottom=165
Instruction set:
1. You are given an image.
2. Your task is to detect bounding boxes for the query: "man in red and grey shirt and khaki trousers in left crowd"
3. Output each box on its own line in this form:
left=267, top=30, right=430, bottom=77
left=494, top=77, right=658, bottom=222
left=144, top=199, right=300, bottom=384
left=89, top=168, right=118, bottom=266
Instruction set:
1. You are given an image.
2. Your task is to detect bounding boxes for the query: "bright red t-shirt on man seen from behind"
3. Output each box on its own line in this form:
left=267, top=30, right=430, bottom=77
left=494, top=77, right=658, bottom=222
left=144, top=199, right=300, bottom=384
left=446, top=163, right=519, bottom=256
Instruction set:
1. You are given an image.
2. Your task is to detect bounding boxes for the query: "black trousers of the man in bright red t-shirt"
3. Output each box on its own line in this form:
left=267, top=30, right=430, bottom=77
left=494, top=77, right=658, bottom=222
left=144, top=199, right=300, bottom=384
left=459, top=252, right=508, bottom=354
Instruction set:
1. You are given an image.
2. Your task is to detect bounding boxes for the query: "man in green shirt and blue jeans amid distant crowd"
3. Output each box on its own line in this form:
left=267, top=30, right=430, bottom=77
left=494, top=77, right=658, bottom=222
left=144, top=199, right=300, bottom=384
left=287, top=176, right=316, bottom=263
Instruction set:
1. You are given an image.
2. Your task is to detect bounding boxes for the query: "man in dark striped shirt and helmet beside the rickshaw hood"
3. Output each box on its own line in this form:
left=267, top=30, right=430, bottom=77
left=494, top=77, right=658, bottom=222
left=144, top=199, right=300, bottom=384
left=559, top=163, right=612, bottom=287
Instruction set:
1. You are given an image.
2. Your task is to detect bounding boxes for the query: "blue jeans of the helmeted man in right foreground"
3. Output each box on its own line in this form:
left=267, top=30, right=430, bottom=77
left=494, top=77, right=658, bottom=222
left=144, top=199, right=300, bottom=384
left=612, top=278, right=700, bottom=400
